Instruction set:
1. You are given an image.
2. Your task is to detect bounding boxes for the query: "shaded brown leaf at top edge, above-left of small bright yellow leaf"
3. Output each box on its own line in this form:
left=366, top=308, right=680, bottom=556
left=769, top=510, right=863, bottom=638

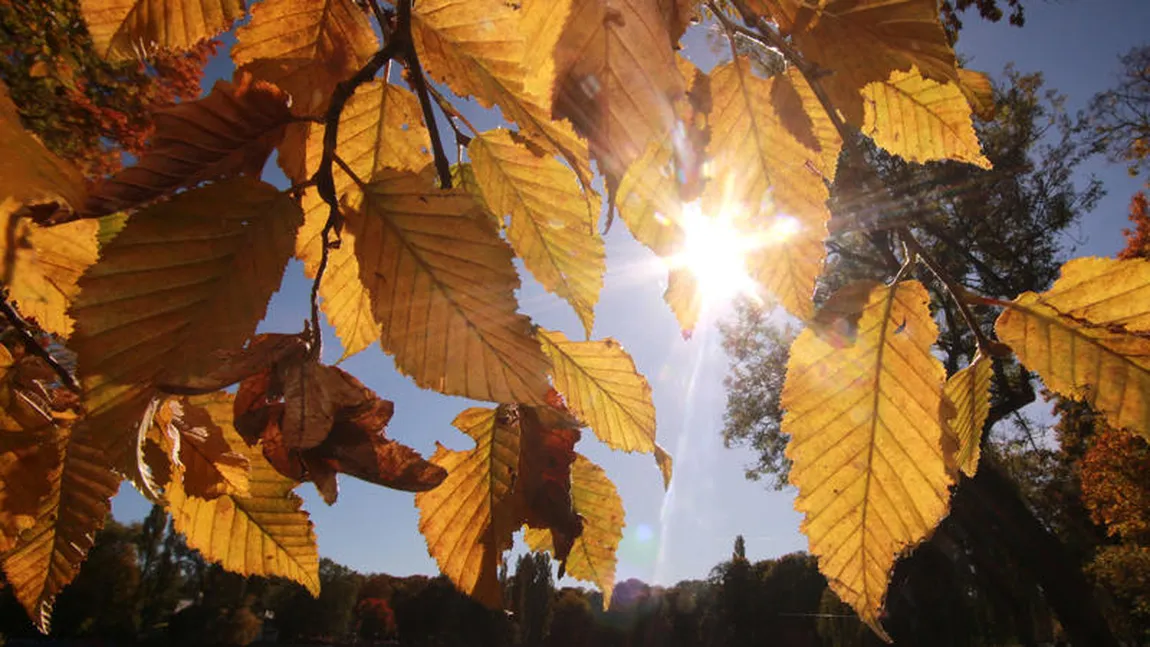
left=794, top=0, right=958, bottom=128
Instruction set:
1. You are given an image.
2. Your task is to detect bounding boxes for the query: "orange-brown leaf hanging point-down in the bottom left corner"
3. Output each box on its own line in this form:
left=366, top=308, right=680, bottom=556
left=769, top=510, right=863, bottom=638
left=3, top=429, right=120, bottom=632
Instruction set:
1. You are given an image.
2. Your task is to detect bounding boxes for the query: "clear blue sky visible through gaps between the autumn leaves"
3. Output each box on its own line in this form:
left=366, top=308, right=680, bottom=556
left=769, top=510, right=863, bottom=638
left=113, top=0, right=1150, bottom=585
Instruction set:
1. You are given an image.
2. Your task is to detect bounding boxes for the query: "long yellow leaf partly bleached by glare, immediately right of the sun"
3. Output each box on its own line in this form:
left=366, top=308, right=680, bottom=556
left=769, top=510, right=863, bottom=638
left=704, top=57, right=838, bottom=318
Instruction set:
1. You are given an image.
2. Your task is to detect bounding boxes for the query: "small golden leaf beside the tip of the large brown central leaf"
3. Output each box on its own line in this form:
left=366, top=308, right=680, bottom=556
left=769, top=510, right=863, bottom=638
left=539, top=329, right=656, bottom=452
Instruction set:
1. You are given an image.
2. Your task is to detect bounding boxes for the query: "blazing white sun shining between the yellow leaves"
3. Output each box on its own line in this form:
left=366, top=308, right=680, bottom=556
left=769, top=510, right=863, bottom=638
left=670, top=202, right=798, bottom=309
